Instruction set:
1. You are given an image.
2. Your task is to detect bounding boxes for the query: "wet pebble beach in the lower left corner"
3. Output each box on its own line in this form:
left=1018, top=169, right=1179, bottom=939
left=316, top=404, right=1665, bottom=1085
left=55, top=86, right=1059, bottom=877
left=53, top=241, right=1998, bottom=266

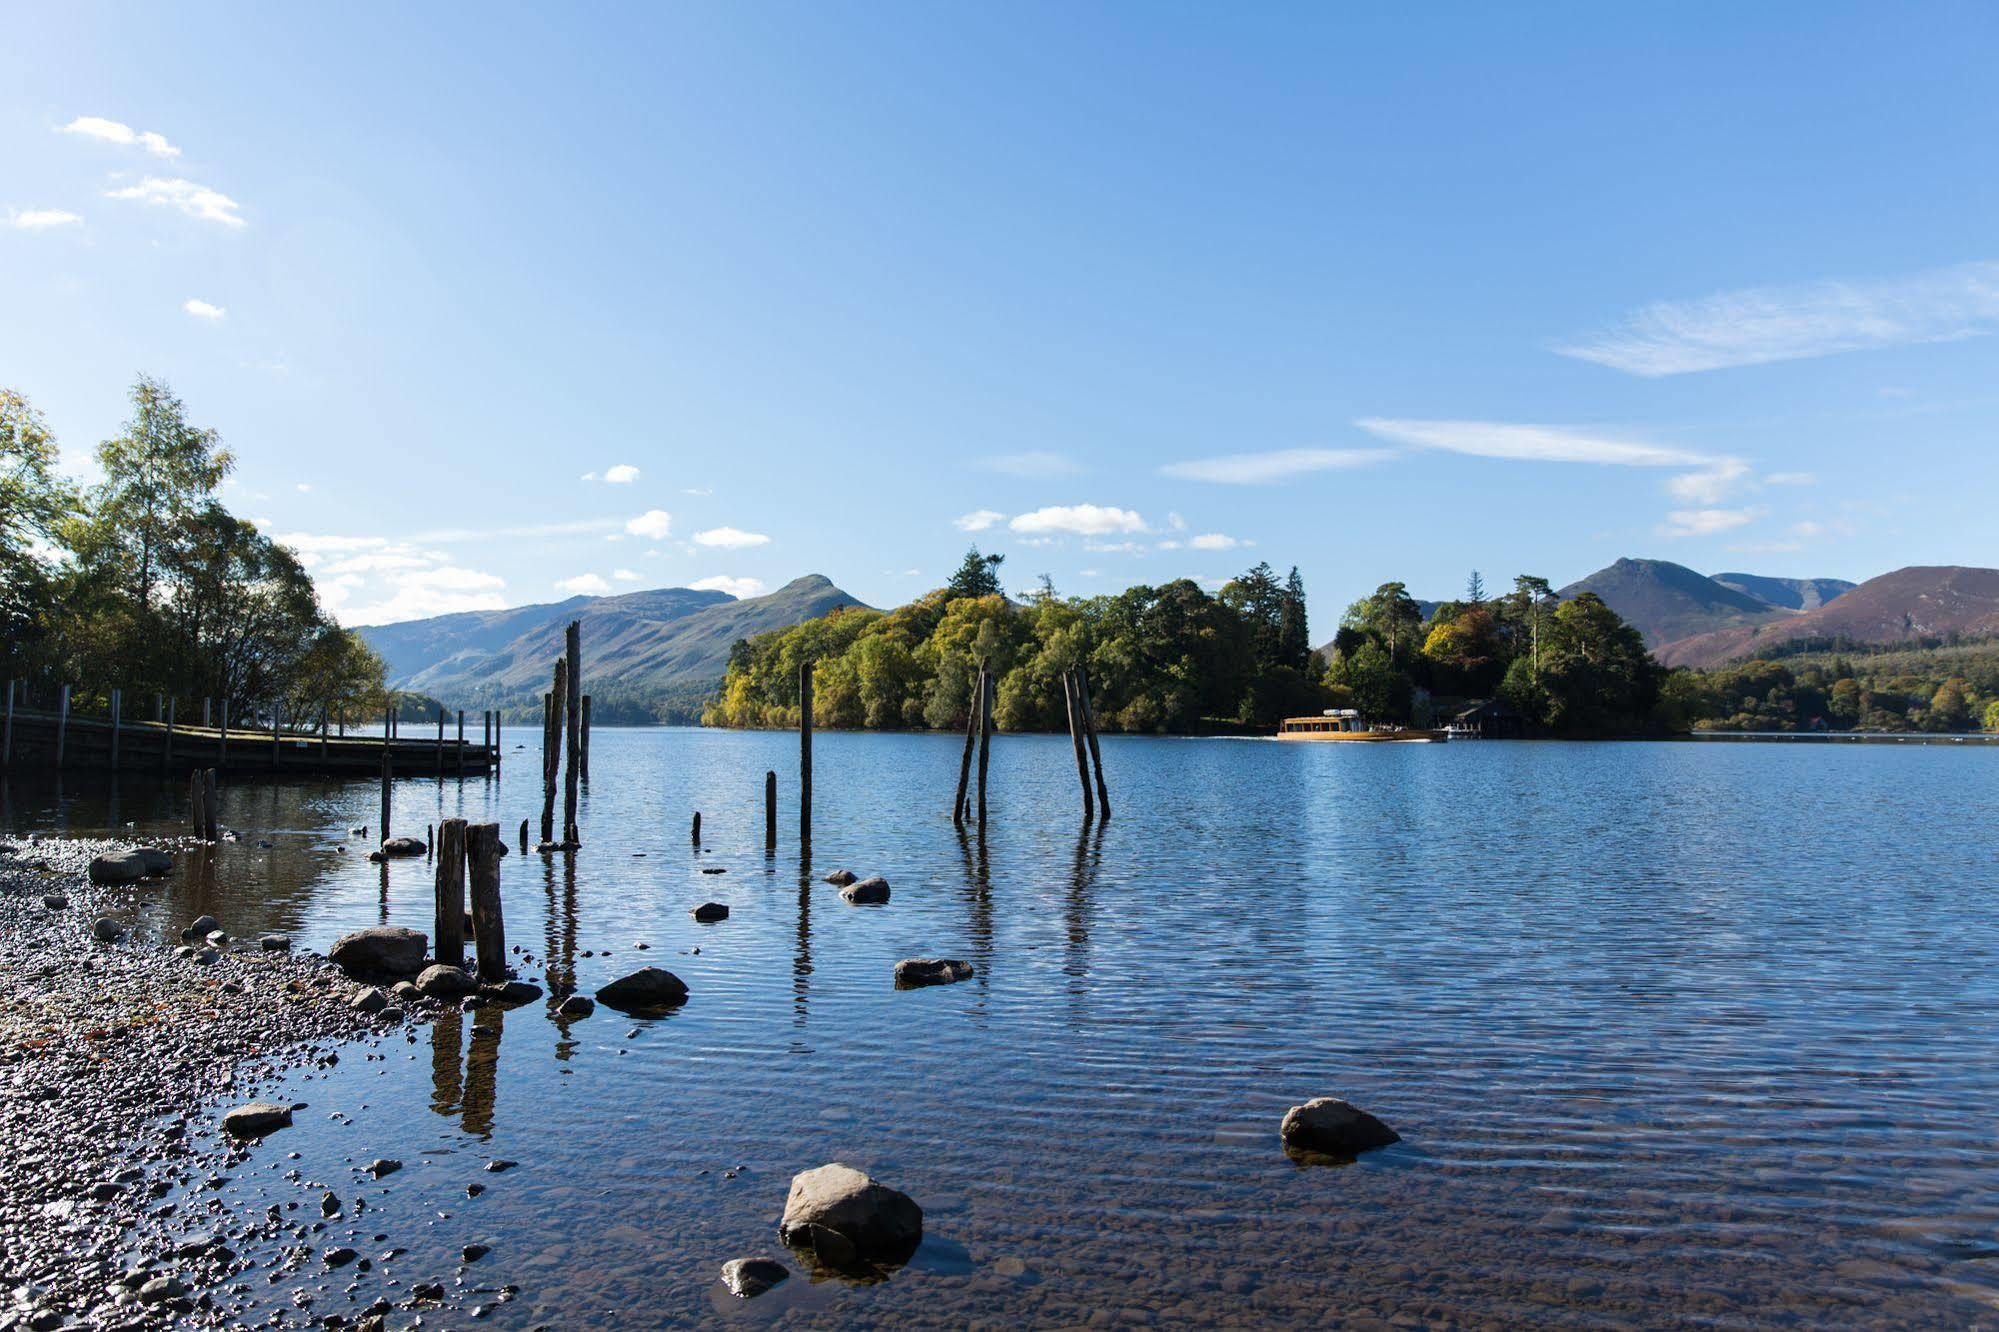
left=0, top=838, right=514, bottom=1332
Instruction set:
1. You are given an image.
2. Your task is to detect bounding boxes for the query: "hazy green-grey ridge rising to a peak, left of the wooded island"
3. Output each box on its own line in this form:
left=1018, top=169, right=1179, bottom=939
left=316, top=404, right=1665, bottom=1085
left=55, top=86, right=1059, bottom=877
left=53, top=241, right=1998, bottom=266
left=358, top=574, right=862, bottom=720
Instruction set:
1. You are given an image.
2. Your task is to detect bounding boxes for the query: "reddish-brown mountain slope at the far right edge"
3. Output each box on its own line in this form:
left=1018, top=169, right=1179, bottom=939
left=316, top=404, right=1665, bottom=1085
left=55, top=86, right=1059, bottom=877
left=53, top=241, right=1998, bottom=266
left=1657, top=564, right=1999, bottom=666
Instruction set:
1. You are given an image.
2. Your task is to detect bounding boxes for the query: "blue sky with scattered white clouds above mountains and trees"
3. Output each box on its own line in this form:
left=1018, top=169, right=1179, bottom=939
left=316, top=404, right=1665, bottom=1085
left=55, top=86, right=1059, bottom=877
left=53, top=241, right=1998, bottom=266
left=0, top=4, right=1999, bottom=636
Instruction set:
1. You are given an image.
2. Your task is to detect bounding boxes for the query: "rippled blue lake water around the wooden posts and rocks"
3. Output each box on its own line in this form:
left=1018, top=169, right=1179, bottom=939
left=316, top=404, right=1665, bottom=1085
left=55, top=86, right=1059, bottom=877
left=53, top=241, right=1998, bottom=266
left=11, top=730, right=1999, bottom=1328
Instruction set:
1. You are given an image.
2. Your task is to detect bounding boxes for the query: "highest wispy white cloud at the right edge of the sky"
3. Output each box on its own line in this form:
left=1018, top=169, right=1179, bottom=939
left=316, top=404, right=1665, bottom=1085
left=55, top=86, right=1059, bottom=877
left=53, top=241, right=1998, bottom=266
left=1553, top=260, right=1999, bottom=378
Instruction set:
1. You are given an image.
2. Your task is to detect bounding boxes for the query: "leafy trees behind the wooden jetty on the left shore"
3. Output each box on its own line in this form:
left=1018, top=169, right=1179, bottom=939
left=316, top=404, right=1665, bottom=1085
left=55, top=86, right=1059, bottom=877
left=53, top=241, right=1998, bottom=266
left=0, top=378, right=384, bottom=724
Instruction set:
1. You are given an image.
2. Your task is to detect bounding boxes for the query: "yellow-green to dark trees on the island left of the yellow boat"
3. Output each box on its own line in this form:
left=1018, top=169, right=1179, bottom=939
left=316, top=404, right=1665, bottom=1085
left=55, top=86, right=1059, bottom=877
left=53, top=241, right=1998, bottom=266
left=702, top=550, right=1325, bottom=732
